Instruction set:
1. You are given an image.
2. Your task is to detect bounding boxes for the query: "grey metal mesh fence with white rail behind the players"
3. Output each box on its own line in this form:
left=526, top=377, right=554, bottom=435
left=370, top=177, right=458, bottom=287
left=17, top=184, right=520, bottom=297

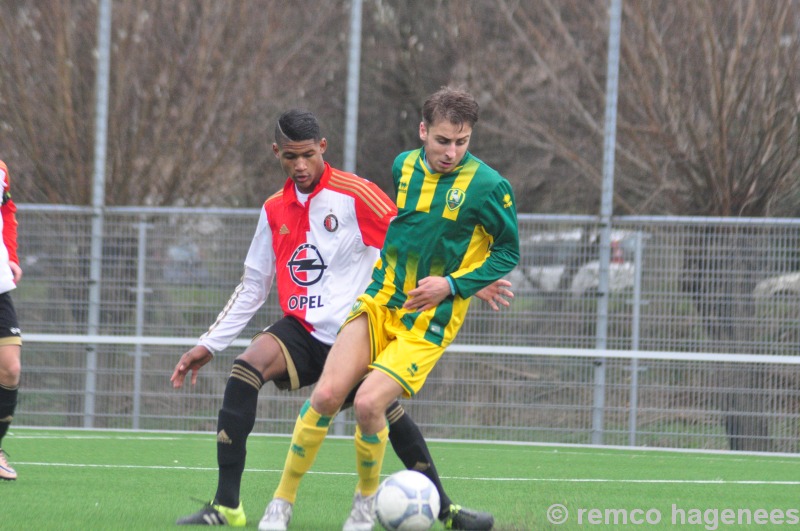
left=13, top=205, right=800, bottom=452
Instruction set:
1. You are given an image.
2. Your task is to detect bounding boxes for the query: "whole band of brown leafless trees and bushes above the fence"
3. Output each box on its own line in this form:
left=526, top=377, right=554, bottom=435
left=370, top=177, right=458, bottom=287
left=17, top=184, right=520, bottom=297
left=0, top=0, right=800, bottom=217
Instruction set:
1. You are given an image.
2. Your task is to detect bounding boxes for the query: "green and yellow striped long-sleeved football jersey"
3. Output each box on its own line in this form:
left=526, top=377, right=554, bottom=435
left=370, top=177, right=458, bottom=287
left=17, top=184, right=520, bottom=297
left=367, top=148, right=519, bottom=345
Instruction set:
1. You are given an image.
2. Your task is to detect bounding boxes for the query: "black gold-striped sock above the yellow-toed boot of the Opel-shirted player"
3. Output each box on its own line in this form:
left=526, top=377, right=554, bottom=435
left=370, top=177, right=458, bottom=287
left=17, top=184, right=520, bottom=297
left=214, top=359, right=264, bottom=508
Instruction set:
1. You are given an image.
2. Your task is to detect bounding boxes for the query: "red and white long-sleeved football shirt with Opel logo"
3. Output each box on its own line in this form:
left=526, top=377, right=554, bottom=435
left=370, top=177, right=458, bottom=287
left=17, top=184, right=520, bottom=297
left=200, top=163, right=397, bottom=352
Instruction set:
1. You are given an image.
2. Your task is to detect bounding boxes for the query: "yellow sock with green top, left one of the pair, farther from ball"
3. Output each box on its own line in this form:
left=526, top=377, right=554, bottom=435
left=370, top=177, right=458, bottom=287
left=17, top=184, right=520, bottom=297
left=274, top=400, right=332, bottom=503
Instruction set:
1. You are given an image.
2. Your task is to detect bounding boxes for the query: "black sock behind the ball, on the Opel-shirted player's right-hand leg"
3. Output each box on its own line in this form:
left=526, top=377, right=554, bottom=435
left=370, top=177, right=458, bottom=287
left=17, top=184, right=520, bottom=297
left=386, top=400, right=452, bottom=516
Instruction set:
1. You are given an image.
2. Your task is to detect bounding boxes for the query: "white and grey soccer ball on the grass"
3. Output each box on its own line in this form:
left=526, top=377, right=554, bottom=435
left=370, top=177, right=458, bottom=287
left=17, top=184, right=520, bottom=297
left=375, top=470, right=440, bottom=531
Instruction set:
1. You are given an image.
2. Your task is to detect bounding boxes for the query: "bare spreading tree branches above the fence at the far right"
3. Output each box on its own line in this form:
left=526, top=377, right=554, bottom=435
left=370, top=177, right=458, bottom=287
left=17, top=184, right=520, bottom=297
left=483, top=0, right=800, bottom=216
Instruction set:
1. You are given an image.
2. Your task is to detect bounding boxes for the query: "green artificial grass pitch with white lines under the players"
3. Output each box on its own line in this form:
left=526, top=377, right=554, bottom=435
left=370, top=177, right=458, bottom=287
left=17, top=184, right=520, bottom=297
left=0, top=428, right=800, bottom=531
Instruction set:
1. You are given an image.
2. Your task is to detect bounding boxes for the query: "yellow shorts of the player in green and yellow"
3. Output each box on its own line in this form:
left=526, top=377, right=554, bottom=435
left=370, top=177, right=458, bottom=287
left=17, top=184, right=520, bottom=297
left=345, top=294, right=445, bottom=398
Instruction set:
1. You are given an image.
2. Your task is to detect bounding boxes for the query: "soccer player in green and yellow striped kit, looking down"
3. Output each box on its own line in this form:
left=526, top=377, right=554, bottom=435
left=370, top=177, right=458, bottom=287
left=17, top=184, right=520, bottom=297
left=259, top=87, right=519, bottom=531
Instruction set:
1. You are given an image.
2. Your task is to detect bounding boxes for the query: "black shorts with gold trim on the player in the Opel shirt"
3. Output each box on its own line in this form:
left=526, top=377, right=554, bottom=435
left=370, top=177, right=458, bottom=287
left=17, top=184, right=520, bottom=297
left=253, top=317, right=331, bottom=391
